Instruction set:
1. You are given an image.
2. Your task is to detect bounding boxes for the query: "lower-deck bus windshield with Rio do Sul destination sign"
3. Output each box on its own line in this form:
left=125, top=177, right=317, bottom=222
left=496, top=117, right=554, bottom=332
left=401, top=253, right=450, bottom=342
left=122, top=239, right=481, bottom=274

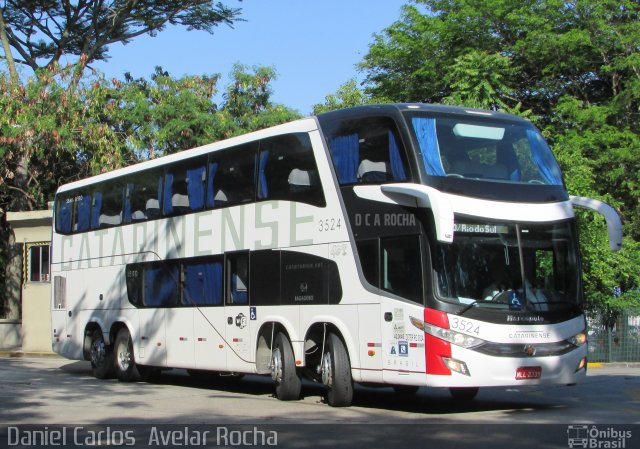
left=434, top=222, right=579, bottom=312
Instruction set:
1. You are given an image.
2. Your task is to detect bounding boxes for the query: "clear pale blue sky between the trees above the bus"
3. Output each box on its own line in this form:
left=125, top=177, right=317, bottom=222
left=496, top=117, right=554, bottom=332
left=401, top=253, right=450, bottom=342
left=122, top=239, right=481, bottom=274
left=92, top=0, right=408, bottom=115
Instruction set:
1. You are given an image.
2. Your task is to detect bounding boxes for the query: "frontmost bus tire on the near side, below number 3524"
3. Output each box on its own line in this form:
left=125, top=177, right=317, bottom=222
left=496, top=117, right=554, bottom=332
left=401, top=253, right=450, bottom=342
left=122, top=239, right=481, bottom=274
left=321, top=334, right=353, bottom=407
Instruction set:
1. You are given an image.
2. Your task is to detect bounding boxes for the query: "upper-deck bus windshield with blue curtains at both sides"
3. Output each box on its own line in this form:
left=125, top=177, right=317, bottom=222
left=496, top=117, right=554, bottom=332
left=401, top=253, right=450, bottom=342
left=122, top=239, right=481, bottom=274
left=407, top=112, right=562, bottom=186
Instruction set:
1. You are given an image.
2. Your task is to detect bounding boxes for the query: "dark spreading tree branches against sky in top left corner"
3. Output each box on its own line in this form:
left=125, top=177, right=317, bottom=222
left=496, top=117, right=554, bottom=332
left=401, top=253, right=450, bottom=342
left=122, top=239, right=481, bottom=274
left=0, top=0, right=241, bottom=82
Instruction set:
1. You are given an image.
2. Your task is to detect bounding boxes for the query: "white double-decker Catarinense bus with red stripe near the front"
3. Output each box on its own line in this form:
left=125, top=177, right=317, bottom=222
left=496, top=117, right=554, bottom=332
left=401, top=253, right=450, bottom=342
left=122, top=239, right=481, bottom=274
left=51, top=104, right=622, bottom=406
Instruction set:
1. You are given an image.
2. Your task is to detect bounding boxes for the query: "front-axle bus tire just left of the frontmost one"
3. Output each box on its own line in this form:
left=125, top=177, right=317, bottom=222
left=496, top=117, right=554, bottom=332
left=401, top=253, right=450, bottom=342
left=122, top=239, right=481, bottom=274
left=271, top=333, right=302, bottom=401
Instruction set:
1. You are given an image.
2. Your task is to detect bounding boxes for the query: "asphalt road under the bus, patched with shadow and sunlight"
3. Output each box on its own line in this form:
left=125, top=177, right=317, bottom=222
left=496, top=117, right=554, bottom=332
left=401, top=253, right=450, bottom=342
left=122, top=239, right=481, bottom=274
left=0, top=357, right=640, bottom=449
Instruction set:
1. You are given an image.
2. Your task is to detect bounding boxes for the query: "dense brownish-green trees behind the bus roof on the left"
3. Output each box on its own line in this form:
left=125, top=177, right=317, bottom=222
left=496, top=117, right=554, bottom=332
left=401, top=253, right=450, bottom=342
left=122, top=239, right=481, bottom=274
left=0, top=65, right=299, bottom=312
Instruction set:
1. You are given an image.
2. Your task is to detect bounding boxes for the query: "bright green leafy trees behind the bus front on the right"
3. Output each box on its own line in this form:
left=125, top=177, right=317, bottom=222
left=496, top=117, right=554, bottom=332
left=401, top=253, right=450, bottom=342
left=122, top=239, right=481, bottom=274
left=359, top=0, right=640, bottom=313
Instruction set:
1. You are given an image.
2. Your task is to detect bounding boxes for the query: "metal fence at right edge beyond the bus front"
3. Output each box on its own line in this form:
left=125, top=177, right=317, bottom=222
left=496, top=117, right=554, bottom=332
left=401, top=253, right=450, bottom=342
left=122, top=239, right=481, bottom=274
left=587, top=309, right=640, bottom=362
